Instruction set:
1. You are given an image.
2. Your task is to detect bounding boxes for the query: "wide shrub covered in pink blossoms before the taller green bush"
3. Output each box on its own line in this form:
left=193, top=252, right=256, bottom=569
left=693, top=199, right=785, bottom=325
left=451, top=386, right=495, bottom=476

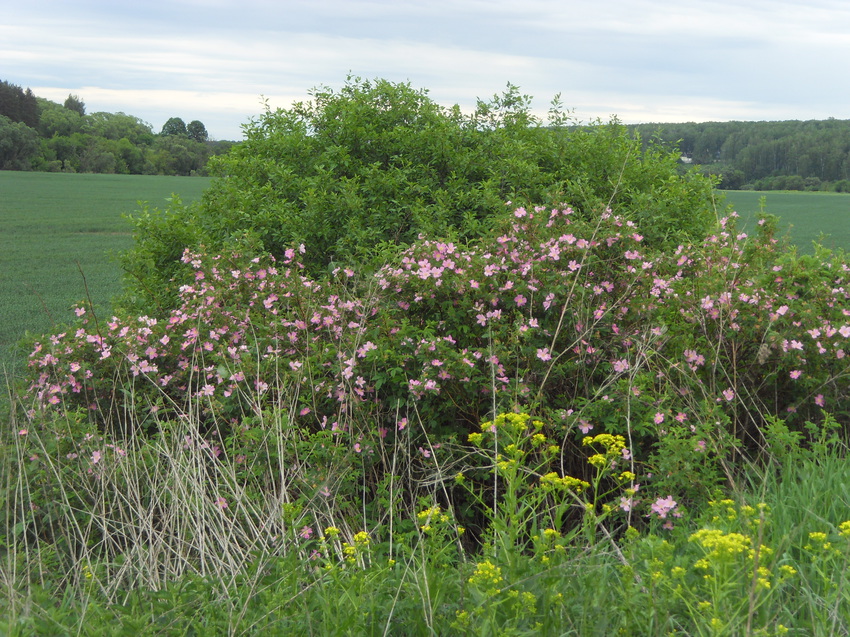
left=18, top=199, right=850, bottom=536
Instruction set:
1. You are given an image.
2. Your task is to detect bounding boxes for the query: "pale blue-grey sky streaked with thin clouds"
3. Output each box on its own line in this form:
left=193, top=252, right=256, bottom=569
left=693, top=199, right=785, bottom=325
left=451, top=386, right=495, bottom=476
left=0, top=0, right=850, bottom=139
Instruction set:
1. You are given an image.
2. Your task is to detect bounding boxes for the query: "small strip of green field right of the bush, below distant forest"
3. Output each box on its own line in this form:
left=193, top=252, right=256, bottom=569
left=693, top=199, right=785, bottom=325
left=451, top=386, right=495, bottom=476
left=724, top=190, right=850, bottom=253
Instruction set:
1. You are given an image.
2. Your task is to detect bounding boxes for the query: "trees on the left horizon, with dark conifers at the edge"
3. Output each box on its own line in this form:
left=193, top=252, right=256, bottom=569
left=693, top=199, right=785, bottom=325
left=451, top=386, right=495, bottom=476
left=0, top=81, right=234, bottom=175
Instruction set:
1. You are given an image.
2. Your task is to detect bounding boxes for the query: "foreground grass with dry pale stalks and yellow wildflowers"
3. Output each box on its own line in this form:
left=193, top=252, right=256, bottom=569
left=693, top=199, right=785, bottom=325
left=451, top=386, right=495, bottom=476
left=0, top=362, right=850, bottom=635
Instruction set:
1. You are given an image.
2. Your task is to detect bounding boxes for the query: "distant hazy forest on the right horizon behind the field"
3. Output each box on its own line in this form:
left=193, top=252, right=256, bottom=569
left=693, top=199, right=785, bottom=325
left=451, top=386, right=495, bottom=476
left=630, top=118, right=850, bottom=192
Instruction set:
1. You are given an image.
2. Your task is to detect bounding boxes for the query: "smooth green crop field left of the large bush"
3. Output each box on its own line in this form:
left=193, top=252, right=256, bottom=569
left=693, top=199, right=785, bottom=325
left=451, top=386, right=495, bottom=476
left=0, top=171, right=210, bottom=364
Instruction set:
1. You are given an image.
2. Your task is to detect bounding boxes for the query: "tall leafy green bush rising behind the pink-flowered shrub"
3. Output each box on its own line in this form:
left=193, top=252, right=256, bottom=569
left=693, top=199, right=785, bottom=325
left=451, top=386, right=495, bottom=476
left=125, top=78, right=714, bottom=305
